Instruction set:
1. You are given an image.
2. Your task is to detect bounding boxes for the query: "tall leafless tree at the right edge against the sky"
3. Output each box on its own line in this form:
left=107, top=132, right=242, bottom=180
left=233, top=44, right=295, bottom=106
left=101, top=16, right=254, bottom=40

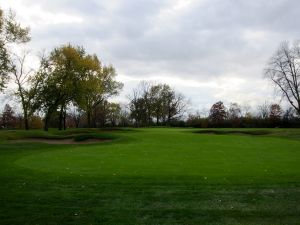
left=265, top=42, right=300, bottom=115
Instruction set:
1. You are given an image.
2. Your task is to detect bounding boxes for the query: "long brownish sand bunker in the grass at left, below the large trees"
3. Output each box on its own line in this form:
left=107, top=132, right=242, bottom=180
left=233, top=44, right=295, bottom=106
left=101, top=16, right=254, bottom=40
left=10, top=138, right=111, bottom=145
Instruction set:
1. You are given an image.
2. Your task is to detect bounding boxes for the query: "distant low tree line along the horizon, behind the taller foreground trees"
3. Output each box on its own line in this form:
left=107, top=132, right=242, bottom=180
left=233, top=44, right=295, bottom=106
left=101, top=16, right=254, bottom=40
left=0, top=95, right=300, bottom=129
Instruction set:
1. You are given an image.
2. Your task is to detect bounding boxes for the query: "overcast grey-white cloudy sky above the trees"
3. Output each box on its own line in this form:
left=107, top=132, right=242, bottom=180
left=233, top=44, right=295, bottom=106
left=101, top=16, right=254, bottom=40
left=0, top=0, right=300, bottom=112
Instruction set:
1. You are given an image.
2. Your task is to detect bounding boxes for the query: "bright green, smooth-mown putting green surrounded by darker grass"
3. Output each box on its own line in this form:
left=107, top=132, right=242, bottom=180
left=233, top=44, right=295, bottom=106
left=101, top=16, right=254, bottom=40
left=15, top=129, right=300, bottom=184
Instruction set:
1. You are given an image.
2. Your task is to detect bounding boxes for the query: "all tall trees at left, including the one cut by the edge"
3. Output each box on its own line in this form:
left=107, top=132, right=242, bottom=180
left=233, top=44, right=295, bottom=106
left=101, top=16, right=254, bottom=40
left=0, top=10, right=123, bottom=131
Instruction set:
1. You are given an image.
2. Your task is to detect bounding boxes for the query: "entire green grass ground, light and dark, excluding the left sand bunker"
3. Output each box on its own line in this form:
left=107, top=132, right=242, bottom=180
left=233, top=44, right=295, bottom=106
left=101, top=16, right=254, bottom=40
left=0, top=128, right=300, bottom=225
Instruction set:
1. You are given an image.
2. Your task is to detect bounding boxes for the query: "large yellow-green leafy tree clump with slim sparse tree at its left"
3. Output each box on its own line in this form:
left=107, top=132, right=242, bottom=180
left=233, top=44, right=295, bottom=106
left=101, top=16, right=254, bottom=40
left=13, top=44, right=122, bottom=131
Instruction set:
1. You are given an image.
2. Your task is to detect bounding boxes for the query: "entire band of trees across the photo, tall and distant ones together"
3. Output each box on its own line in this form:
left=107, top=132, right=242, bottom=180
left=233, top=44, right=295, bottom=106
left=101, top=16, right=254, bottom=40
left=0, top=9, right=300, bottom=131
